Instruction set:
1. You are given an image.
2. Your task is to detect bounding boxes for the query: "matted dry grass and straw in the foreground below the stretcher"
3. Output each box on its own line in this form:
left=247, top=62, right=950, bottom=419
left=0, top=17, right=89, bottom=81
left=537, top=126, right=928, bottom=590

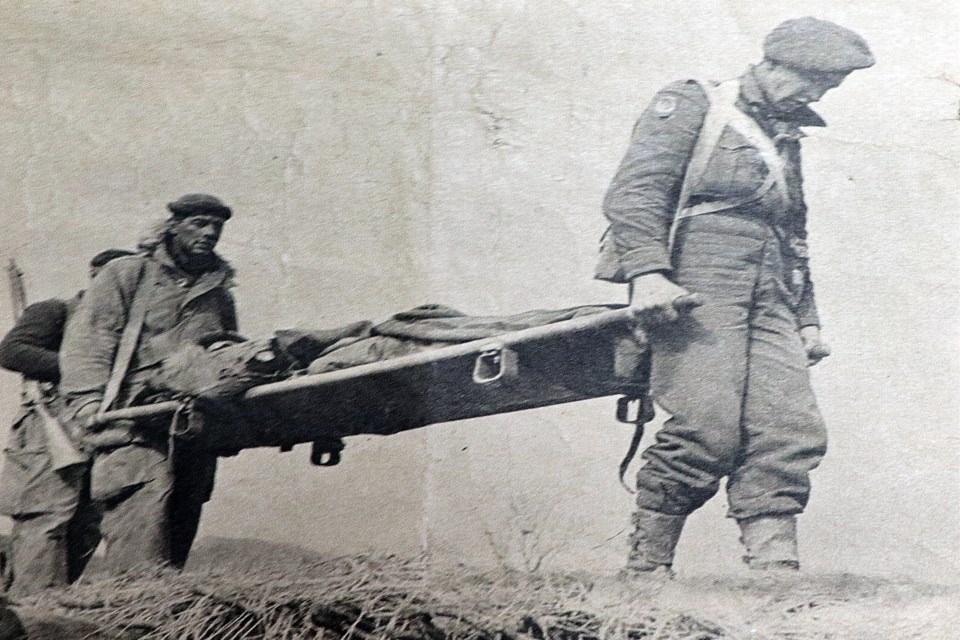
left=16, top=558, right=732, bottom=640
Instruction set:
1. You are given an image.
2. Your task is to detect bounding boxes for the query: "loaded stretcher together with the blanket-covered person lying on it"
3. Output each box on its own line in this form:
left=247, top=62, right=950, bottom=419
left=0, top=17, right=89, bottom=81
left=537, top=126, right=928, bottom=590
left=92, top=305, right=688, bottom=464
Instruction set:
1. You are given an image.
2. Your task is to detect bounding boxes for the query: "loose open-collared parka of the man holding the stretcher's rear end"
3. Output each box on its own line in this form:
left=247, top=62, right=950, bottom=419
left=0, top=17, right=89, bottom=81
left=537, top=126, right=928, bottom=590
left=60, top=246, right=237, bottom=502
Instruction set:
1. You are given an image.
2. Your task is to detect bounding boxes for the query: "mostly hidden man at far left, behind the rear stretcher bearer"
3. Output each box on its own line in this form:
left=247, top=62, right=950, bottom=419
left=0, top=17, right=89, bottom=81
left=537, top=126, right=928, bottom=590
left=0, top=249, right=132, bottom=596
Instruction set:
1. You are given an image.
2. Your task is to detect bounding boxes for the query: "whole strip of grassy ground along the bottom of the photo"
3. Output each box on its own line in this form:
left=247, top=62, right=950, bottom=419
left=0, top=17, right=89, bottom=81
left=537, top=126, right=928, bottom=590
left=9, top=541, right=960, bottom=640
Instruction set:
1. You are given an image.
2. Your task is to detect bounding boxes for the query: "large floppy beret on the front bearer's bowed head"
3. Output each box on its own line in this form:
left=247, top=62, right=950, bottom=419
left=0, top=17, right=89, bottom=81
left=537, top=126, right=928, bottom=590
left=763, top=16, right=874, bottom=73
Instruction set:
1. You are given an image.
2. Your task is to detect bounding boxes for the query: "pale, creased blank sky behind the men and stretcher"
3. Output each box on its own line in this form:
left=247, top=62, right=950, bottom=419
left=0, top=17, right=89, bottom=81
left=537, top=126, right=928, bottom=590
left=0, top=0, right=960, bottom=581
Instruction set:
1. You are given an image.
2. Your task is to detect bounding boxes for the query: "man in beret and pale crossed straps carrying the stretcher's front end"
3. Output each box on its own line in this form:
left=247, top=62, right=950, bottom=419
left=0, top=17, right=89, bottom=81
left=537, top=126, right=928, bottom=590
left=596, top=18, right=874, bottom=576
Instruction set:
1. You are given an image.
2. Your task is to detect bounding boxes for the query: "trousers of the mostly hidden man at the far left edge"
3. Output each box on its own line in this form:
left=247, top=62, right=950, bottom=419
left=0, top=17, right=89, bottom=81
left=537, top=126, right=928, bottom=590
left=0, top=413, right=100, bottom=596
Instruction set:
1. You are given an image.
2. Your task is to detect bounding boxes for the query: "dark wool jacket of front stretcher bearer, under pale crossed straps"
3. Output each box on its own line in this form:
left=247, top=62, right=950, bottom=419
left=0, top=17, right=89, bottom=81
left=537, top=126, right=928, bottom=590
left=596, top=68, right=825, bottom=326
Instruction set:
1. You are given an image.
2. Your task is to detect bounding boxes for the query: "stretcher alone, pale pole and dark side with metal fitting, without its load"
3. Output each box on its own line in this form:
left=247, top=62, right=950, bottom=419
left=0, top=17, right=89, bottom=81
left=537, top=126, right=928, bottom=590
left=94, top=300, right=696, bottom=451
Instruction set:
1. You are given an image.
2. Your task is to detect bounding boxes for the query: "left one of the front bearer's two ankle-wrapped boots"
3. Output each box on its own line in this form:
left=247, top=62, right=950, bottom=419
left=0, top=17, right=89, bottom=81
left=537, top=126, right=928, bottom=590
left=620, top=509, right=687, bottom=578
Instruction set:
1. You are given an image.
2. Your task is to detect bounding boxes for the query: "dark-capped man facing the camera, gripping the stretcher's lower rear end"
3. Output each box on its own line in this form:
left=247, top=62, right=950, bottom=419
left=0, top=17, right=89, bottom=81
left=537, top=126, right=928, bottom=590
left=60, top=194, right=237, bottom=572
